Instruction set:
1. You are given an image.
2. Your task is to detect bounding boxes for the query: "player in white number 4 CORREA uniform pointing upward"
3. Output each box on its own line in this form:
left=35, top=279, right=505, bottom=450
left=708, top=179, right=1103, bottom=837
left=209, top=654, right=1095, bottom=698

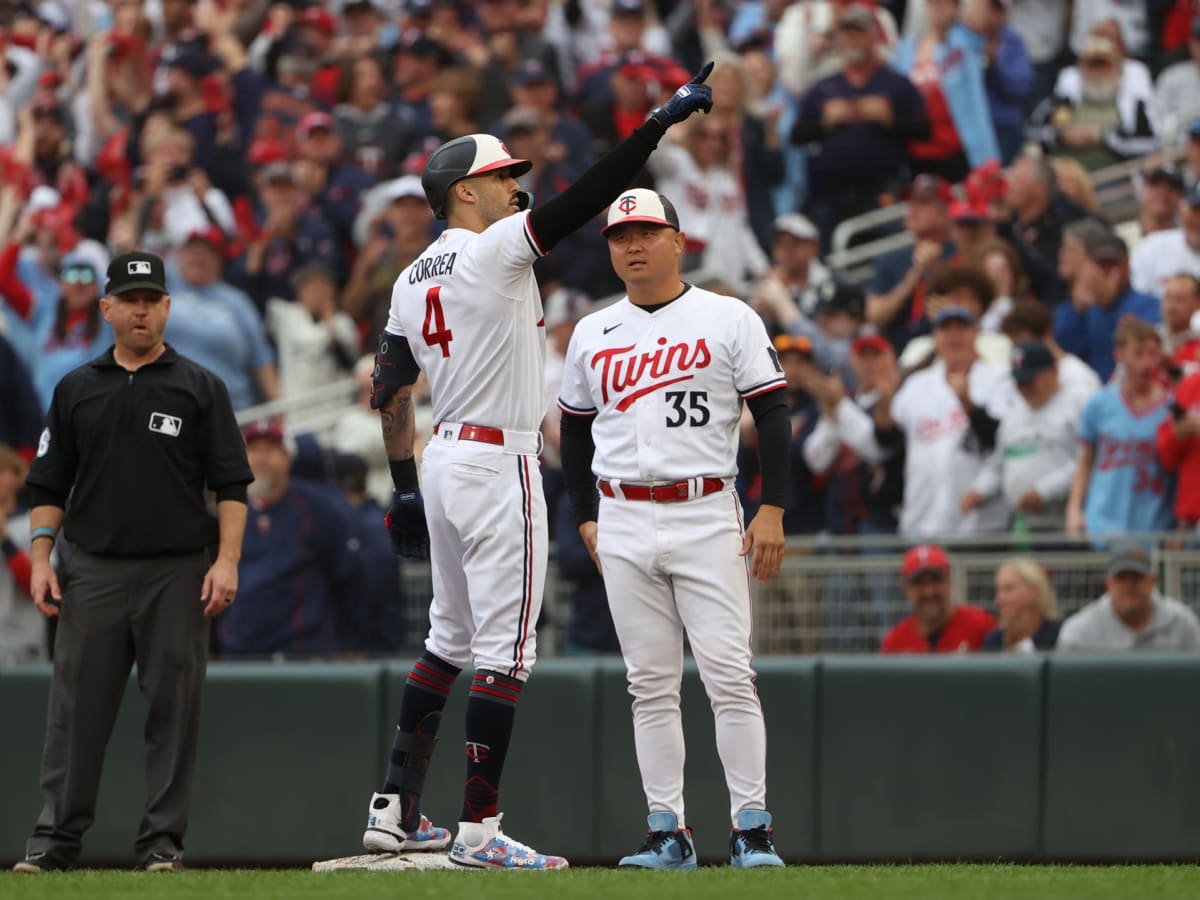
left=362, top=64, right=712, bottom=869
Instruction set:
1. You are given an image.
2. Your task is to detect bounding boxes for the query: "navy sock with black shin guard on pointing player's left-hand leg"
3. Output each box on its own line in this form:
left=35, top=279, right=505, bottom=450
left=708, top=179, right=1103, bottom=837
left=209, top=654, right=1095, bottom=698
left=380, top=650, right=462, bottom=832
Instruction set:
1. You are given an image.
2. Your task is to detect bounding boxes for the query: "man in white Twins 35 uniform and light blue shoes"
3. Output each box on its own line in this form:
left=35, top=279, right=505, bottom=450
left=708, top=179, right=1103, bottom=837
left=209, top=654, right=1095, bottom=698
left=559, top=190, right=791, bottom=869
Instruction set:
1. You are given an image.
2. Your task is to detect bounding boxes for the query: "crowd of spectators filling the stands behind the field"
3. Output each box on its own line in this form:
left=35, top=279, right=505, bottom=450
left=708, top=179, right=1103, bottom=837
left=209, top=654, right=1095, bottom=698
left=0, top=0, right=1200, bottom=660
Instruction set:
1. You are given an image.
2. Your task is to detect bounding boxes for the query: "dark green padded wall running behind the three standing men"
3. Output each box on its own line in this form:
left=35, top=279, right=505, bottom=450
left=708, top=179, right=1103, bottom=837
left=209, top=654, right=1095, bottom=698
left=0, top=655, right=1200, bottom=865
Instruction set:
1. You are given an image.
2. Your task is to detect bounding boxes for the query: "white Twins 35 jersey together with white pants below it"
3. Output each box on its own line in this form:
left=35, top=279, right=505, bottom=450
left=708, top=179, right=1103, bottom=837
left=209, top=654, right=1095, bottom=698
left=558, top=280, right=785, bottom=827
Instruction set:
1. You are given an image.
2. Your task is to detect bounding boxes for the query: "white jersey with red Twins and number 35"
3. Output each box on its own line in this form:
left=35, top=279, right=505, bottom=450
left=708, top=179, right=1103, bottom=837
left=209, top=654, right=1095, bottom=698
left=558, top=287, right=785, bottom=481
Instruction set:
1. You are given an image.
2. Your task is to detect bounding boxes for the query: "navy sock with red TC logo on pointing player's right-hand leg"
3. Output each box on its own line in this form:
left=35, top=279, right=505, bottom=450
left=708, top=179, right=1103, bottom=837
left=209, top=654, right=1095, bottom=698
left=458, top=670, right=522, bottom=822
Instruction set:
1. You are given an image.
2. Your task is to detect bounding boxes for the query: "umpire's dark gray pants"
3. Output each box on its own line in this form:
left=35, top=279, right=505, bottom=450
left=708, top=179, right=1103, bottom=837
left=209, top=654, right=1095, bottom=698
left=26, top=548, right=209, bottom=865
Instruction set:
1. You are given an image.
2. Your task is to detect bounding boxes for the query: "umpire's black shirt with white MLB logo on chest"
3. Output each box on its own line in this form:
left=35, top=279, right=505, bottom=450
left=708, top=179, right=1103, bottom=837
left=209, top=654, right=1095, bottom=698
left=26, top=346, right=253, bottom=557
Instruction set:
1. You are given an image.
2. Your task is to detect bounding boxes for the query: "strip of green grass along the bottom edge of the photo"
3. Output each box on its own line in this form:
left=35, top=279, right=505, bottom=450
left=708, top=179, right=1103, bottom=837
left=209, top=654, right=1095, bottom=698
left=0, top=865, right=1200, bottom=900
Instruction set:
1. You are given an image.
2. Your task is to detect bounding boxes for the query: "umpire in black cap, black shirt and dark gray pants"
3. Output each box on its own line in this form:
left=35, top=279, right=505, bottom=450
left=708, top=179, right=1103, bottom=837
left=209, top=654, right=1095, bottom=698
left=13, top=253, right=253, bottom=874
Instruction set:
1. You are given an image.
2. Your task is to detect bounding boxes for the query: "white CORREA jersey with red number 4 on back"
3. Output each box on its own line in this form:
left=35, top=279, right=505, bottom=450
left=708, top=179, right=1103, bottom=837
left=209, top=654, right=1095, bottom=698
left=388, top=212, right=546, bottom=432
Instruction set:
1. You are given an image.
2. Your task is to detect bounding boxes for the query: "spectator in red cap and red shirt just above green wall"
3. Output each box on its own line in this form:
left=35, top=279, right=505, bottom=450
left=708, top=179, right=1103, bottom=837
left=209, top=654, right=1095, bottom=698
left=883, top=544, right=996, bottom=653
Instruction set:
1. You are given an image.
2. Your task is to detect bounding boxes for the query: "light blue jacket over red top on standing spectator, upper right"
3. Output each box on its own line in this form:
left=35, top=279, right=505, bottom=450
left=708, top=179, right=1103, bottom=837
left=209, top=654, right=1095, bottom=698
left=892, top=25, right=1000, bottom=168
